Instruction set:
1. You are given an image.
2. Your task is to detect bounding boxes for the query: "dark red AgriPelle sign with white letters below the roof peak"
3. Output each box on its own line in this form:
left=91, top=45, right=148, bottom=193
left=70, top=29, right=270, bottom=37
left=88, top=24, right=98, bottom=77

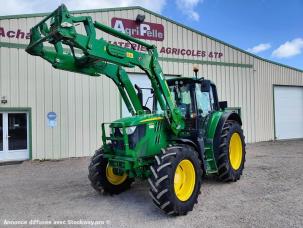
left=111, top=17, right=164, bottom=41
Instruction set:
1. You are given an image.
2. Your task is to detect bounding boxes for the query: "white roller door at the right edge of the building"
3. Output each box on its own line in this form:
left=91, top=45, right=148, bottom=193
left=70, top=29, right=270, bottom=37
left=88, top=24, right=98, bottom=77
left=274, top=86, right=303, bottom=139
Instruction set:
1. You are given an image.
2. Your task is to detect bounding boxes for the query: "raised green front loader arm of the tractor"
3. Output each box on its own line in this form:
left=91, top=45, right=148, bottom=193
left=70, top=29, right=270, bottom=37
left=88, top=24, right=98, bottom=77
left=26, top=5, right=184, bottom=134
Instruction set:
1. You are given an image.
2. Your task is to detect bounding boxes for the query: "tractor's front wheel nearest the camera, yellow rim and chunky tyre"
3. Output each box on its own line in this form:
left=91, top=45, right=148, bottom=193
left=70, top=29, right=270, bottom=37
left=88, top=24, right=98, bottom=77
left=148, top=145, right=202, bottom=215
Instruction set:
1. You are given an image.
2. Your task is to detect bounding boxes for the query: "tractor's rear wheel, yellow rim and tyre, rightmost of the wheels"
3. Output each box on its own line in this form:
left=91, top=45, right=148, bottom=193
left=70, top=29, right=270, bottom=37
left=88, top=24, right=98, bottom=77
left=216, top=121, right=246, bottom=182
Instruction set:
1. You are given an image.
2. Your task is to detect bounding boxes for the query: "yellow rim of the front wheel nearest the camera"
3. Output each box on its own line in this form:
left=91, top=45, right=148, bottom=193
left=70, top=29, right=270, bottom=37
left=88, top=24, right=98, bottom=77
left=174, top=160, right=196, bottom=201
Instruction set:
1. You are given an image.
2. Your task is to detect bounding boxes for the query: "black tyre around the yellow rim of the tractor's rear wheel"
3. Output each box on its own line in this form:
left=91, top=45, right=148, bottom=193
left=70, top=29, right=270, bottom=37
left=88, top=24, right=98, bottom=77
left=215, top=120, right=246, bottom=182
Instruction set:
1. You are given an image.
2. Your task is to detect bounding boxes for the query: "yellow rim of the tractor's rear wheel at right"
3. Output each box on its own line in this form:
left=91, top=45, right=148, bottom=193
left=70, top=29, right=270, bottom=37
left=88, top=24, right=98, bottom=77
left=229, top=132, right=242, bottom=170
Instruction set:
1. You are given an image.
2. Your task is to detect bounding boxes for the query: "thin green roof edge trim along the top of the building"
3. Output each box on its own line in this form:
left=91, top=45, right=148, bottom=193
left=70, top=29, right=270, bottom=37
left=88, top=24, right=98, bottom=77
left=0, top=6, right=303, bottom=73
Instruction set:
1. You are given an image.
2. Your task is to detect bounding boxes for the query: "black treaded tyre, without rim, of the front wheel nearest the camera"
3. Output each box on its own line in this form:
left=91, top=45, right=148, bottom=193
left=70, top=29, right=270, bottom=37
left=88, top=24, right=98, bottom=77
left=148, top=145, right=202, bottom=215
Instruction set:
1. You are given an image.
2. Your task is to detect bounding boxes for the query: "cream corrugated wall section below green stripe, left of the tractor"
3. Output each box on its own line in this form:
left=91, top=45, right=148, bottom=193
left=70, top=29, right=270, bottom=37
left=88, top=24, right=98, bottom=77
left=0, top=45, right=120, bottom=159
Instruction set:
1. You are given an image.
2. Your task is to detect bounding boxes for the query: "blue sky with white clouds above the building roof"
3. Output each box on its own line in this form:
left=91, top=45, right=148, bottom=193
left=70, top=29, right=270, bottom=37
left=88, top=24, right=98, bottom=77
left=0, top=0, right=303, bottom=69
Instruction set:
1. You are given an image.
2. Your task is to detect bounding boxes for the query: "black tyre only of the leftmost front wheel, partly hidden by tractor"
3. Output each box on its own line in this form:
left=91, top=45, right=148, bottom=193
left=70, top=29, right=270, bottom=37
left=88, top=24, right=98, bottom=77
left=88, top=148, right=134, bottom=194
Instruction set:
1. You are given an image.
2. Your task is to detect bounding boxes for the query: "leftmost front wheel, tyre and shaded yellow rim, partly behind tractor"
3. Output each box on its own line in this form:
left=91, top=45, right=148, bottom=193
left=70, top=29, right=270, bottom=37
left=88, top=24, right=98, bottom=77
left=88, top=148, right=133, bottom=194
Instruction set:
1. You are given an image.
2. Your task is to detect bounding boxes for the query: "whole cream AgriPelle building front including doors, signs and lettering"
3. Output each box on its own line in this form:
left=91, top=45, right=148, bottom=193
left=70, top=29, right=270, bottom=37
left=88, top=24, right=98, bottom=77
left=0, top=7, right=303, bottom=162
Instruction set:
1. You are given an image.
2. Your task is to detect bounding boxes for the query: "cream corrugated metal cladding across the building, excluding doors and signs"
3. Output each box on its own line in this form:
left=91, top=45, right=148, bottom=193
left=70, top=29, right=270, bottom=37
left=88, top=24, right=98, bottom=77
left=0, top=9, right=303, bottom=159
